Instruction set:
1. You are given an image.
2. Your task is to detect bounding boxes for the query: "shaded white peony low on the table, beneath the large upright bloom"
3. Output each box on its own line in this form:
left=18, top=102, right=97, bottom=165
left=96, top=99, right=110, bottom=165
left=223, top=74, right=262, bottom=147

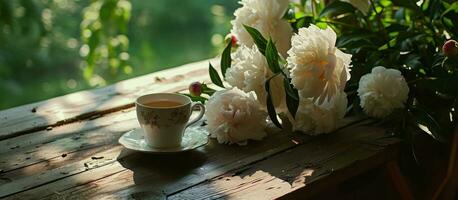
left=289, top=92, right=347, bottom=135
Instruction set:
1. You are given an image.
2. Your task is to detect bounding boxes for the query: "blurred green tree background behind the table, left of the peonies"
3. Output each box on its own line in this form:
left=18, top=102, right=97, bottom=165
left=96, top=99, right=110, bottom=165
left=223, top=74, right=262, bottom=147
left=0, top=0, right=238, bottom=109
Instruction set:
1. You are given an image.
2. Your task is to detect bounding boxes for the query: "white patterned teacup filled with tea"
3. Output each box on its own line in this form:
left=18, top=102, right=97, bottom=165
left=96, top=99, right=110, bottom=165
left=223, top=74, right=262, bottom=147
left=135, top=93, right=205, bottom=148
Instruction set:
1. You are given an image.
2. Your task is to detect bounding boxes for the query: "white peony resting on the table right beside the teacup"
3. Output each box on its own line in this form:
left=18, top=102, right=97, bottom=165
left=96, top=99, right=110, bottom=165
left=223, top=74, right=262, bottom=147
left=206, top=88, right=267, bottom=145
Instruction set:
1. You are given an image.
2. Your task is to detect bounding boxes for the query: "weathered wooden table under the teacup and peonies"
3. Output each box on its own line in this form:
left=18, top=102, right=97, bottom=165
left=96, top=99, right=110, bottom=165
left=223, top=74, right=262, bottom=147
left=0, top=60, right=398, bottom=199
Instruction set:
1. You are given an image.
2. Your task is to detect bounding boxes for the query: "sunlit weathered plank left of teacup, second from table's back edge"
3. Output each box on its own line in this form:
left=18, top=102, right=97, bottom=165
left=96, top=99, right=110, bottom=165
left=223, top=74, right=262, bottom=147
left=0, top=109, right=204, bottom=197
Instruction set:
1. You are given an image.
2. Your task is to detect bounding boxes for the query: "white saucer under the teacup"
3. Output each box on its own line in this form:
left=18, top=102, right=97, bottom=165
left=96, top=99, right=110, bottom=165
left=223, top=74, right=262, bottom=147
left=118, top=126, right=208, bottom=153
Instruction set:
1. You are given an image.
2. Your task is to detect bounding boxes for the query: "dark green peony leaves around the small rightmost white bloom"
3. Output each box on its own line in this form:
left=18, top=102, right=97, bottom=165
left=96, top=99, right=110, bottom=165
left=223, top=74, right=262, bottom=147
left=285, top=0, right=458, bottom=141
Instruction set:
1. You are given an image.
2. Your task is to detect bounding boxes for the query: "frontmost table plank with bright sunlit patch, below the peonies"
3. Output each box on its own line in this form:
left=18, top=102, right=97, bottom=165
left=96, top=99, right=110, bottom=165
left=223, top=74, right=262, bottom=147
left=168, top=124, right=397, bottom=199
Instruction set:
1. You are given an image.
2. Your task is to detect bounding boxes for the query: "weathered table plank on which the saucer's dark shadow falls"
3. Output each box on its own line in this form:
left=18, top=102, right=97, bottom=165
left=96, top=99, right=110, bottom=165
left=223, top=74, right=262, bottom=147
left=0, top=118, right=364, bottom=199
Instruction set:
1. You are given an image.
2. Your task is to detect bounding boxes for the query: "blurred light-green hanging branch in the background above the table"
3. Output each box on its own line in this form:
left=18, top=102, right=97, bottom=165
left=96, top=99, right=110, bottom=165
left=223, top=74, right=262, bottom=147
left=80, top=0, right=132, bottom=85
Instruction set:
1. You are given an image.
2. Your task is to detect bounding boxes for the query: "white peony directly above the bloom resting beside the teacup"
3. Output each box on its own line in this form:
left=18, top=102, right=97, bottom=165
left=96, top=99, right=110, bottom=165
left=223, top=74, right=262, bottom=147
left=226, top=45, right=286, bottom=112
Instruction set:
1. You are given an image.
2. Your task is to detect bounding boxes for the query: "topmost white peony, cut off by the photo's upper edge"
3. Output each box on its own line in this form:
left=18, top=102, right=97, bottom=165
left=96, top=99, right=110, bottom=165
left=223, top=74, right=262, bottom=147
left=231, top=0, right=293, bottom=57
